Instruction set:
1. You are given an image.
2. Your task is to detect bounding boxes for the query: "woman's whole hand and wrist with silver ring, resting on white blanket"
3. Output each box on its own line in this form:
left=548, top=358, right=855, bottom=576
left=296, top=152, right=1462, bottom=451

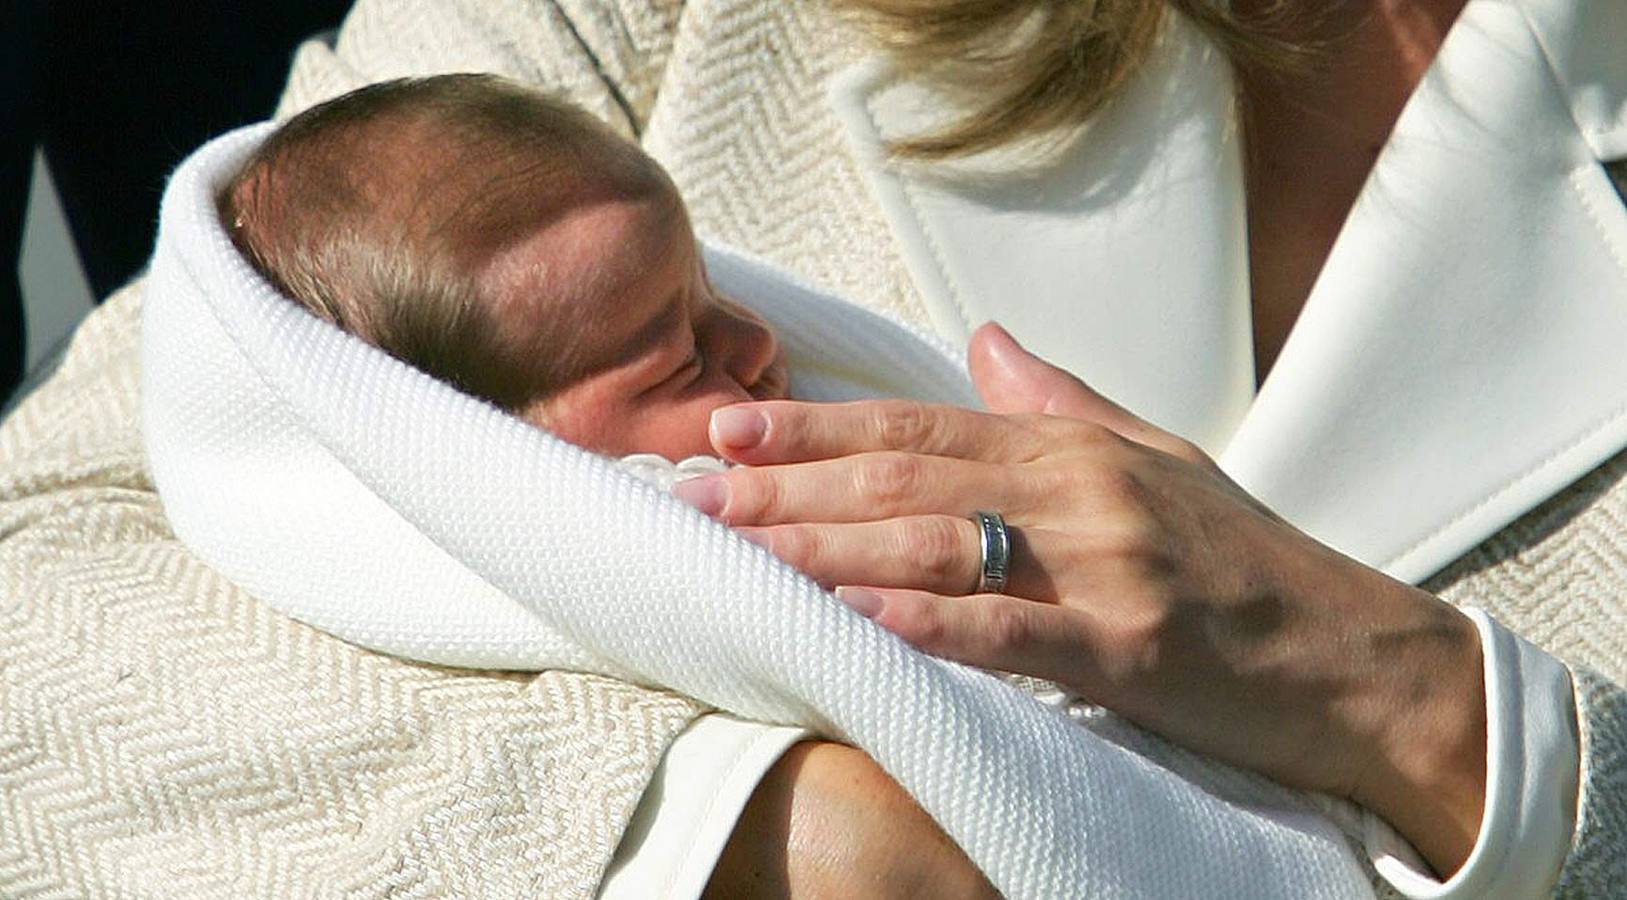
left=683, top=325, right=1485, bottom=872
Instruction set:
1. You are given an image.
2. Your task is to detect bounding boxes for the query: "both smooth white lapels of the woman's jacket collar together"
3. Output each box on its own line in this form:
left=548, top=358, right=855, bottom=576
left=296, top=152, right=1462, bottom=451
left=833, top=0, right=1627, bottom=579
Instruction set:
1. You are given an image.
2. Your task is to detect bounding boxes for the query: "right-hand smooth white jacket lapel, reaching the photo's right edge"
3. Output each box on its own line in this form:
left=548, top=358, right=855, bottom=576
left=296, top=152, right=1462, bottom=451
left=1222, top=0, right=1627, bottom=579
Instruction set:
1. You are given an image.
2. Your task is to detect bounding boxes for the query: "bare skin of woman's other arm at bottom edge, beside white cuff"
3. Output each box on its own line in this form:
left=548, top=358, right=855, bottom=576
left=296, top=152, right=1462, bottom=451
left=706, top=742, right=999, bottom=900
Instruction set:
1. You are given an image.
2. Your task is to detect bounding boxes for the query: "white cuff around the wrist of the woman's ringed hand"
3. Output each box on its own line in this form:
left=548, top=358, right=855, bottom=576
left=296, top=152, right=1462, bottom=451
left=1365, top=609, right=1581, bottom=900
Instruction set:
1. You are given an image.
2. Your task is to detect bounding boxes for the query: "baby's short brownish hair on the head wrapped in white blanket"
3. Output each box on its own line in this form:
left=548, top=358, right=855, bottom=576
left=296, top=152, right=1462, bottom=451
left=216, top=75, right=675, bottom=412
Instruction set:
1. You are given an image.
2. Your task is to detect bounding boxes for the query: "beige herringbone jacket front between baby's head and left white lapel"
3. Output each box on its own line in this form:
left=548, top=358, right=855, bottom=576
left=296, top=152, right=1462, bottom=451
left=644, top=0, right=926, bottom=322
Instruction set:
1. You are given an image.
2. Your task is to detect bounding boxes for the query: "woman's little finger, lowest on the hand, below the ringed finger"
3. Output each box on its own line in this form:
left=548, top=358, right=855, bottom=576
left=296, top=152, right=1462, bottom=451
left=836, top=586, right=1101, bottom=687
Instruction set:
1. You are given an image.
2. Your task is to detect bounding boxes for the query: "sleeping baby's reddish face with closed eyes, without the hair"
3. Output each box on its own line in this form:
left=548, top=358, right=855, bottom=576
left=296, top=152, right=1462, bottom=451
left=486, top=187, right=786, bottom=461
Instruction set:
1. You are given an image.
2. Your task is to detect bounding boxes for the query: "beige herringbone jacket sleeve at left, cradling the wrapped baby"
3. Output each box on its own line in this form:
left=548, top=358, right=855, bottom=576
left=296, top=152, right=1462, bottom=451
left=0, top=2, right=700, bottom=900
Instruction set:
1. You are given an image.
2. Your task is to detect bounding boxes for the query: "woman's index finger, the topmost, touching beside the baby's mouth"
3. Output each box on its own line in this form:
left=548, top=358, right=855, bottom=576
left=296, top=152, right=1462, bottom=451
left=709, top=400, right=1045, bottom=465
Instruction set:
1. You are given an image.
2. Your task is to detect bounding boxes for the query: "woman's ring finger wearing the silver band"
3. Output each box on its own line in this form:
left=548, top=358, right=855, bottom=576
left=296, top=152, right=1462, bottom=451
left=740, top=516, right=1056, bottom=601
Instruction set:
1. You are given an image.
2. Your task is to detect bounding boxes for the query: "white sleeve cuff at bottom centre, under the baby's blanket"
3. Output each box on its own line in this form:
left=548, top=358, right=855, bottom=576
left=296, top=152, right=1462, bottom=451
left=599, top=713, right=810, bottom=900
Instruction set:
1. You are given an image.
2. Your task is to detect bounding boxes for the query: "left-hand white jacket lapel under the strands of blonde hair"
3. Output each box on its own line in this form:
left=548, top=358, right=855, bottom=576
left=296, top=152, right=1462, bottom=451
left=831, top=13, right=1254, bottom=449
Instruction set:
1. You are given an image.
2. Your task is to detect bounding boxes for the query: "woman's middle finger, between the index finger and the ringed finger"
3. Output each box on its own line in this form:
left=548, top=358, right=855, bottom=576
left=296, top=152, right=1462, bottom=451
left=672, top=452, right=1033, bottom=526
